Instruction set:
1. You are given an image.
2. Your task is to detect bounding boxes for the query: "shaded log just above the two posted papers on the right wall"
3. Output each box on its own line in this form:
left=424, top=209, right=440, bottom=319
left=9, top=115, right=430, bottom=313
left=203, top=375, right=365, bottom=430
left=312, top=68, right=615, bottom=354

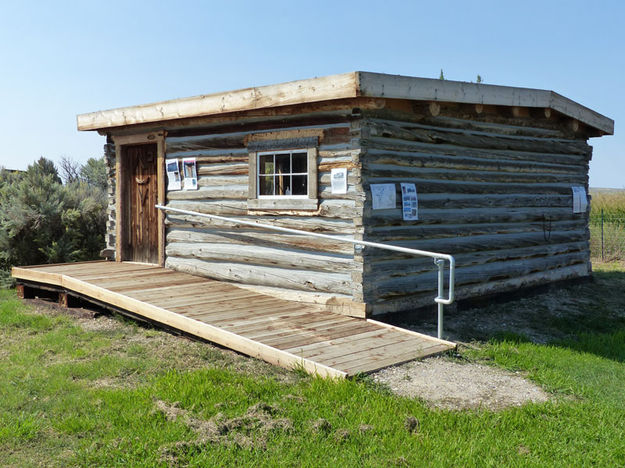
left=362, top=161, right=588, bottom=185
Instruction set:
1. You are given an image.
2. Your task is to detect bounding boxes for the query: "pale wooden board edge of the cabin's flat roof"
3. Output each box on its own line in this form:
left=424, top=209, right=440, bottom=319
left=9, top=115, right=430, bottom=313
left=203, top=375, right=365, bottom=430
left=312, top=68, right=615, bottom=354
left=77, top=71, right=614, bottom=135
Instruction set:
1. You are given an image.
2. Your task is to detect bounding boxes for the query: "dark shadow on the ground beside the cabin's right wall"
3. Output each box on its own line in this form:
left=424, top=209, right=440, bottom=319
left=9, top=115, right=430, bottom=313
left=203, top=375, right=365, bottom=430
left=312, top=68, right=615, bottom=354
left=388, top=263, right=625, bottom=362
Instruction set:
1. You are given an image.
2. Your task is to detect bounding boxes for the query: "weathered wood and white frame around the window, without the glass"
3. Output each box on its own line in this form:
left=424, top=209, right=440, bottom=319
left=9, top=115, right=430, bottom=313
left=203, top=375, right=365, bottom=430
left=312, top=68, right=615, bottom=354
left=247, top=147, right=319, bottom=211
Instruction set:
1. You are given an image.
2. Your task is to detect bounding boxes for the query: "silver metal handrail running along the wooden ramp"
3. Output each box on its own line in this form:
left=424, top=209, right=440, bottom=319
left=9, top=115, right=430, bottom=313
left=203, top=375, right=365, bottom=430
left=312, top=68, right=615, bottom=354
left=155, top=205, right=456, bottom=339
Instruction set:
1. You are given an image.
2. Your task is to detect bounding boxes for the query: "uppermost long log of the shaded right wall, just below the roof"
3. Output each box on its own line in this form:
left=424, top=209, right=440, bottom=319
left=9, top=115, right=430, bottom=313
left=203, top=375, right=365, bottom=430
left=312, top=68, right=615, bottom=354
left=367, top=120, right=592, bottom=156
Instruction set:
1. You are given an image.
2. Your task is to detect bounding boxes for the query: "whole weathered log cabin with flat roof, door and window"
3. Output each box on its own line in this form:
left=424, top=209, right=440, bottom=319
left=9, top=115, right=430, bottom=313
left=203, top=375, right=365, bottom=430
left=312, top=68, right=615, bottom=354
left=77, top=72, right=614, bottom=317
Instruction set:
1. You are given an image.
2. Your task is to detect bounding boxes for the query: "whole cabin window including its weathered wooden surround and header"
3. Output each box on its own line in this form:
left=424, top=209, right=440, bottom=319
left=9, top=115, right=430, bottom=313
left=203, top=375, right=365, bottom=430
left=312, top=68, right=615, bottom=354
left=247, top=137, right=318, bottom=211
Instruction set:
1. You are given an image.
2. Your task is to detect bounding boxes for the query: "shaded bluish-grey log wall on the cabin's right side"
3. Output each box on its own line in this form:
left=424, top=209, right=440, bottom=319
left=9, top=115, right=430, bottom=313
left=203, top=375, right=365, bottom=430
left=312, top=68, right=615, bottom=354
left=361, top=112, right=592, bottom=314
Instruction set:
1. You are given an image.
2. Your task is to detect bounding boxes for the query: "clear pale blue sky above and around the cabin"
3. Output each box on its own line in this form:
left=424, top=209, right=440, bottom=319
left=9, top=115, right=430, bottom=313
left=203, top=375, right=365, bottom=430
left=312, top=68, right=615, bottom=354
left=0, top=0, right=625, bottom=188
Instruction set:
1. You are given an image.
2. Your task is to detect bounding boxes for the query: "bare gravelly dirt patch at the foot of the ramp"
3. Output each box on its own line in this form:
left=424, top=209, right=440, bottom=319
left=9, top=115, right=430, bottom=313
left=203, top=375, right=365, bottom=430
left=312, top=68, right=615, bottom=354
left=372, top=357, right=550, bottom=410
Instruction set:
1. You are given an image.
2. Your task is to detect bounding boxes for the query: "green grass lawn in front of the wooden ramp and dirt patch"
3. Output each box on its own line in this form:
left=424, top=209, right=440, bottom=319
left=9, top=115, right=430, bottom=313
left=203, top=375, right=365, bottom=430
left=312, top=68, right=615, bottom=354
left=0, top=267, right=625, bottom=467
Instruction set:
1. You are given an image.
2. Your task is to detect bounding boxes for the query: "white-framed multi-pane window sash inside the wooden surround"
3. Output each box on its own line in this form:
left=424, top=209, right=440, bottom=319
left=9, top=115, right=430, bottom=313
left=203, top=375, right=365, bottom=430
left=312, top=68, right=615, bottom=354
left=257, top=150, right=308, bottom=198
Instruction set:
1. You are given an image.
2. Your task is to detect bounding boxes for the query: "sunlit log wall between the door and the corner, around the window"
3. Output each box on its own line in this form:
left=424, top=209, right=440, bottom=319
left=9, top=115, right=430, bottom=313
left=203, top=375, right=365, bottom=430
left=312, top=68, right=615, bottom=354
left=165, top=108, right=364, bottom=313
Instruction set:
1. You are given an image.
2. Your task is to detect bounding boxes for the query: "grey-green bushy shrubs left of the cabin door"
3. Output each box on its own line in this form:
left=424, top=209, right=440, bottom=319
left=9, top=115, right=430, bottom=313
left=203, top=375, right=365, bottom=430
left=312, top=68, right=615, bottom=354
left=0, top=158, right=107, bottom=286
